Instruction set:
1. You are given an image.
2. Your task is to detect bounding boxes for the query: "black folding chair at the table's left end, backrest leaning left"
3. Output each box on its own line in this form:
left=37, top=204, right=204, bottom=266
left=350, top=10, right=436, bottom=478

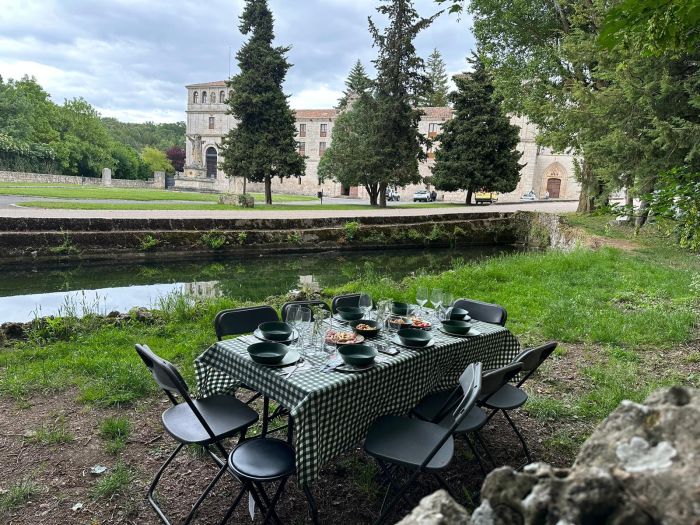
left=136, top=345, right=258, bottom=525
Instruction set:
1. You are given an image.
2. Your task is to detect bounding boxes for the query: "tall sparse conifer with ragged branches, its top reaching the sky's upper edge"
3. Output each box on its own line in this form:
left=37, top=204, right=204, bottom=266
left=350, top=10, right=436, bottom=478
left=369, top=0, right=437, bottom=207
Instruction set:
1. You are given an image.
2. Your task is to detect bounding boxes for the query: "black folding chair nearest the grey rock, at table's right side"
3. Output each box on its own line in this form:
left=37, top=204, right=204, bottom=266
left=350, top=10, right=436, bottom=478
left=364, top=363, right=481, bottom=523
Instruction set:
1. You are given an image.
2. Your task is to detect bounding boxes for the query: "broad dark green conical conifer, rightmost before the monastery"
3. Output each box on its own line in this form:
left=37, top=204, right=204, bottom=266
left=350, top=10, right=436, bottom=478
left=433, top=55, right=523, bottom=205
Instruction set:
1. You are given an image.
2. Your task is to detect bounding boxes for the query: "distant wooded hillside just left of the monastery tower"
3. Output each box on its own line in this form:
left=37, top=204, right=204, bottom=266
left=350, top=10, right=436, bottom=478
left=102, top=118, right=185, bottom=151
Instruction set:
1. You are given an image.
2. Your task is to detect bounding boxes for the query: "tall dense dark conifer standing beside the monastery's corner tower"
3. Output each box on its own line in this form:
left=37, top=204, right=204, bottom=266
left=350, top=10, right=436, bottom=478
left=222, top=0, right=304, bottom=204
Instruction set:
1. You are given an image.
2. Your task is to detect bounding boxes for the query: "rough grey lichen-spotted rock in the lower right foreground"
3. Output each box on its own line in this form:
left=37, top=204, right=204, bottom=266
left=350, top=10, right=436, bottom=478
left=401, top=387, right=700, bottom=525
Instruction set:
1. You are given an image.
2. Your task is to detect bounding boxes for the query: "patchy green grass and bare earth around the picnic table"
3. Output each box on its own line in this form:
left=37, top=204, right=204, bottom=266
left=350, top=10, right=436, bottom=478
left=0, top=214, right=700, bottom=524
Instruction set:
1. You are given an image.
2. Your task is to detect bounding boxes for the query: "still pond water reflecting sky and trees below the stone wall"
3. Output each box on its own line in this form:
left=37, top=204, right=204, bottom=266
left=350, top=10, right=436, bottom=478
left=0, top=247, right=510, bottom=323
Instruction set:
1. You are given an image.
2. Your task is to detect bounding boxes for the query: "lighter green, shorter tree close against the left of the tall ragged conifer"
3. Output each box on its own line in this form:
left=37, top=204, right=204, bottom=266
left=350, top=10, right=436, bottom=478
left=318, top=61, right=379, bottom=206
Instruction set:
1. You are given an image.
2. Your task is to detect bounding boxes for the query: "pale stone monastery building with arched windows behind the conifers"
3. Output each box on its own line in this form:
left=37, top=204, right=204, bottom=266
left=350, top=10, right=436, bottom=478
left=180, top=80, right=580, bottom=202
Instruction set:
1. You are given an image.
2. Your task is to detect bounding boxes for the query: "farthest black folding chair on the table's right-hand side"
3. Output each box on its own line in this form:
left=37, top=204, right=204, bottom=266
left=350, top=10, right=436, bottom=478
left=479, top=342, right=557, bottom=463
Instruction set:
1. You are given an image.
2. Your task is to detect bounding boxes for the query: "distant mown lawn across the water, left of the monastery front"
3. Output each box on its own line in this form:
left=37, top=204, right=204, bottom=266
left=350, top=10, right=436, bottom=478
left=0, top=182, right=317, bottom=203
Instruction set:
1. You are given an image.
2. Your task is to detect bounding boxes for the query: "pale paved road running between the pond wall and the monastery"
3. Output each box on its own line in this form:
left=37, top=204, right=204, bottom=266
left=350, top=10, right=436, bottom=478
left=0, top=195, right=577, bottom=219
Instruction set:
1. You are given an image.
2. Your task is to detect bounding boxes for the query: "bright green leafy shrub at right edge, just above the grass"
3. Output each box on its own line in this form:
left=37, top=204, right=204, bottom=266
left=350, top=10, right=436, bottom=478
left=651, top=168, right=700, bottom=251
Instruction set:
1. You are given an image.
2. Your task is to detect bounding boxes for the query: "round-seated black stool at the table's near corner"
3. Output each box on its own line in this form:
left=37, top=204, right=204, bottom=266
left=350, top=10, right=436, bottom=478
left=220, top=438, right=295, bottom=525
